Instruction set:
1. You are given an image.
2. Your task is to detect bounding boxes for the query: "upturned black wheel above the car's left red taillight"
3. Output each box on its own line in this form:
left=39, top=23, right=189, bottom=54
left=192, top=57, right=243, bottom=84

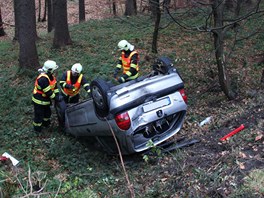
left=90, top=79, right=110, bottom=117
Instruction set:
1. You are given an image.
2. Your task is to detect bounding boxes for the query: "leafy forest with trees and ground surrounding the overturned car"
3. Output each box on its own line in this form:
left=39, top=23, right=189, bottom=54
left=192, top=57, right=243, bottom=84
left=0, top=0, right=264, bottom=197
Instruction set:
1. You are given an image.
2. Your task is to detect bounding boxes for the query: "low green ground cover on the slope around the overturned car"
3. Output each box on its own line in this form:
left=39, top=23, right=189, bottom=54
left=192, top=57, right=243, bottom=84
left=0, top=7, right=264, bottom=198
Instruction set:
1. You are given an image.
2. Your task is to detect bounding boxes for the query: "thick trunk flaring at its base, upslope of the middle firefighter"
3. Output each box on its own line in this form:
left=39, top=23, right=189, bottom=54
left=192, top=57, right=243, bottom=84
left=53, top=0, right=72, bottom=48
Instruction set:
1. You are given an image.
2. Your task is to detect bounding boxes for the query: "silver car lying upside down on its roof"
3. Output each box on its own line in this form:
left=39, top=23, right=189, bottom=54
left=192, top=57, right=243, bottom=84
left=56, top=57, right=187, bottom=155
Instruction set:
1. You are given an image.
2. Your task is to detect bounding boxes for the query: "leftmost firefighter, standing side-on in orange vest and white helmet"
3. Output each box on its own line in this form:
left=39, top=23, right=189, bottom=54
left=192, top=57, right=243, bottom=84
left=32, top=60, right=59, bottom=132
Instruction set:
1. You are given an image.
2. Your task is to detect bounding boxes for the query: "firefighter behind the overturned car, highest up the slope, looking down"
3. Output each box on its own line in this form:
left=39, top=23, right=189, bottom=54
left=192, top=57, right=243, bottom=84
left=114, top=40, right=139, bottom=83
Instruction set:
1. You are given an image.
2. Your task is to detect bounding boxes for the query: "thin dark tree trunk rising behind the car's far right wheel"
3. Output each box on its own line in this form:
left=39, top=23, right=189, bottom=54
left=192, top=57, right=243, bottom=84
left=152, top=0, right=161, bottom=53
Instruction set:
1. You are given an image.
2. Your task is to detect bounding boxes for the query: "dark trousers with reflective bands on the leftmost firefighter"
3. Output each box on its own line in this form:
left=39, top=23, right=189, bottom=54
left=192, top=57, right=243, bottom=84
left=33, top=103, right=51, bottom=132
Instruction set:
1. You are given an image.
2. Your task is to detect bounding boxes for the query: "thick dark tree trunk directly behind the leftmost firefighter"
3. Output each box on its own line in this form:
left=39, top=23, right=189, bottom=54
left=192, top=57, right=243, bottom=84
left=17, top=0, right=39, bottom=69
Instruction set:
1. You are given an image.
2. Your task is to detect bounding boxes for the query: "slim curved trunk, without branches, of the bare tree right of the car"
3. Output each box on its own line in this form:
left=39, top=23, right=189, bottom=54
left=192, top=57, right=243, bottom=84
left=212, top=0, right=235, bottom=100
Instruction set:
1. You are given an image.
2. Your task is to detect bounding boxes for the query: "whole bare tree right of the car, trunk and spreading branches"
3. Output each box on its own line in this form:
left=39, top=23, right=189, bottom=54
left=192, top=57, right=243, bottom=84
left=164, top=0, right=264, bottom=99
